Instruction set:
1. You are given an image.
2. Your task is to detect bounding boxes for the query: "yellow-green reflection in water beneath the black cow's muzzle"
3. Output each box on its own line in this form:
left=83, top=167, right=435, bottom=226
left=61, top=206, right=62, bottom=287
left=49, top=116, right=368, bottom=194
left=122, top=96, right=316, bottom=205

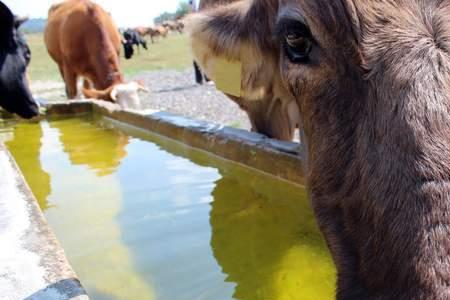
left=5, top=123, right=51, bottom=209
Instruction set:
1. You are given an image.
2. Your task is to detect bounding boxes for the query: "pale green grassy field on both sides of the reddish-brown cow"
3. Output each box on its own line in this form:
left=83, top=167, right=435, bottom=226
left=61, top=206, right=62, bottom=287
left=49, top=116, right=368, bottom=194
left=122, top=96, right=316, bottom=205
left=27, top=34, right=192, bottom=81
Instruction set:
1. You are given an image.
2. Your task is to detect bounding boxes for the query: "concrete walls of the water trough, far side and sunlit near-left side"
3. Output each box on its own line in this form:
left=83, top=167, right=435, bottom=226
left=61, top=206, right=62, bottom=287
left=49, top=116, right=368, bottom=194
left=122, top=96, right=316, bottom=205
left=0, top=100, right=305, bottom=300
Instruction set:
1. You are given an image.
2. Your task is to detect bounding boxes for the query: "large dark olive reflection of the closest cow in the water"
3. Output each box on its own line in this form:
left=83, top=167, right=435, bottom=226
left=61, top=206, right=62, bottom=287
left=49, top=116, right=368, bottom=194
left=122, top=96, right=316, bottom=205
left=210, top=174, right=335, bottom=300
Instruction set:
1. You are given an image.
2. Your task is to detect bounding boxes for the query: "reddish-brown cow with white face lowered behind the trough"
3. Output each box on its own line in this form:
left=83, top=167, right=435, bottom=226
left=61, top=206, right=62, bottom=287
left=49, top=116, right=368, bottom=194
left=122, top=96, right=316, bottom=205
left=45, top=0, right=147, bottom=108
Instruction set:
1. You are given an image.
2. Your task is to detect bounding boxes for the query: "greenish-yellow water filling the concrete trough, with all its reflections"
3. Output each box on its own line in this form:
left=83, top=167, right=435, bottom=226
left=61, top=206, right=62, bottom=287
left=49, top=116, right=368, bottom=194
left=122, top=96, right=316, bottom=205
left=0, top=117, right=335, bottom=300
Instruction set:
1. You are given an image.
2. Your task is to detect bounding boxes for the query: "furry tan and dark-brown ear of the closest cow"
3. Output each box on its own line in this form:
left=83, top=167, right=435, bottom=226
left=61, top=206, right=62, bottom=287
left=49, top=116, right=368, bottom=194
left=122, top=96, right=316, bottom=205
left=186, top=0, right=279, bottom=100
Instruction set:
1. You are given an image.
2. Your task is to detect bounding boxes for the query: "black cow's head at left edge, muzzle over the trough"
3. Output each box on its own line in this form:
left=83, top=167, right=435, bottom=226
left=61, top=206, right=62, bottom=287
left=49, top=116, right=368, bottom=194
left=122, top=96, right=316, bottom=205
left=0, top=1, right=39, bottom=119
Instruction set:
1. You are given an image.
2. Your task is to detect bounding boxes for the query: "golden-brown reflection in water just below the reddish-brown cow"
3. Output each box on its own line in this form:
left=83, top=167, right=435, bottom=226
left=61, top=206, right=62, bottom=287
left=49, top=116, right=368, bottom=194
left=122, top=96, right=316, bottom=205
left=50, top=120, right=129, bottom=177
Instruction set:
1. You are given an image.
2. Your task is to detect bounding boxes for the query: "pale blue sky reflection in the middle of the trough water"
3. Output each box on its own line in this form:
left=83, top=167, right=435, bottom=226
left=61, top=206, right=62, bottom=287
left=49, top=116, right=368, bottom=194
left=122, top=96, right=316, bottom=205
left=117, top=139, right=229, bottom=300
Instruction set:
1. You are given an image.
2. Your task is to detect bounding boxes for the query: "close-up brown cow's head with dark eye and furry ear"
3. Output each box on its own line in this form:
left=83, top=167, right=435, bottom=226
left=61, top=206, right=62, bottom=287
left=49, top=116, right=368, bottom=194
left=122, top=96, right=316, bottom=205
left=190, top=0, right=450, bottom=299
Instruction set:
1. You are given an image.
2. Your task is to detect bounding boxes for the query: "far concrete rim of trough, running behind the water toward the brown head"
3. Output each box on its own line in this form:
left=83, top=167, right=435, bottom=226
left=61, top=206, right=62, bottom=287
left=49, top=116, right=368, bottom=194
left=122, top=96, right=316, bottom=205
left=40, top=100, right=305, bottom=185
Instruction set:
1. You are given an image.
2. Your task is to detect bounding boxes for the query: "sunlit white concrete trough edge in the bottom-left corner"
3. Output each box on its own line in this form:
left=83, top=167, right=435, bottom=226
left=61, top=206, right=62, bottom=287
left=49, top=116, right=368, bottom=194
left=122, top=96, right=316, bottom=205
left=0, top=143, right=89, bottom=300
